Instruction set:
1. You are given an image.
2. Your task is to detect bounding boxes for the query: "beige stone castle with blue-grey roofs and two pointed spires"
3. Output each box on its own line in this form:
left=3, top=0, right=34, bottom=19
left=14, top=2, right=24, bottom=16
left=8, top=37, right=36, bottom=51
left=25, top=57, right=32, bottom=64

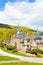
left=3, top=25, right=43, bottom=52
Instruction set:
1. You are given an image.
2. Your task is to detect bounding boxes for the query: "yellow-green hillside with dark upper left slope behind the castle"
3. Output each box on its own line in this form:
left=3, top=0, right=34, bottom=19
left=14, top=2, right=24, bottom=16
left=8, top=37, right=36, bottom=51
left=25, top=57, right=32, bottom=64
left=0, top=24, right=41, bottom=46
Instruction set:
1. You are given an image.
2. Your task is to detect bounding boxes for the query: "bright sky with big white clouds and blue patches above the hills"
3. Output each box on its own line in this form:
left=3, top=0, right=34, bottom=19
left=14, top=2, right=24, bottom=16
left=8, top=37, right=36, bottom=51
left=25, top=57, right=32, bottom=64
left=0, top=0, right=43, bottom=31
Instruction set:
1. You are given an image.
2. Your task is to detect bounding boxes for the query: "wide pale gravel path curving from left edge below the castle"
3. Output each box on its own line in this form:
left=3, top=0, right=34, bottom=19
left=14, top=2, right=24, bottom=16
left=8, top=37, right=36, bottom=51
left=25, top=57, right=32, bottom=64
left=0, top=49, right=43, bottom=64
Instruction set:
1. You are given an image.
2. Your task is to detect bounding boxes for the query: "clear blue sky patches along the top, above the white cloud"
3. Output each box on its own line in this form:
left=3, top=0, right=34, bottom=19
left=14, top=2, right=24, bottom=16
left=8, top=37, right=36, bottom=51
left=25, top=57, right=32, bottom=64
left=0, top=0, right=35, bottom=11
